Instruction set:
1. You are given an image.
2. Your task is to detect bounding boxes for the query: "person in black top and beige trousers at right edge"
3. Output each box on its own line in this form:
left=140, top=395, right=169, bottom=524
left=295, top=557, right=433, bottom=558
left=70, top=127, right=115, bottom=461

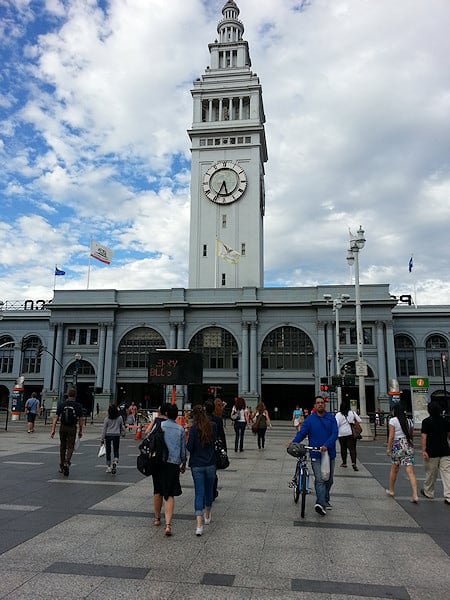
left=420, top=400, right=450, bottom=504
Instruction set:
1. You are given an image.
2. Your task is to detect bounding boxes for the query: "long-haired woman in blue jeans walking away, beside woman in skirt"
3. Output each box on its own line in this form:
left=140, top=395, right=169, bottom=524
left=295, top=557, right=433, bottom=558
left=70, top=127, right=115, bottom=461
left=187, top=404, right=217, bottom=536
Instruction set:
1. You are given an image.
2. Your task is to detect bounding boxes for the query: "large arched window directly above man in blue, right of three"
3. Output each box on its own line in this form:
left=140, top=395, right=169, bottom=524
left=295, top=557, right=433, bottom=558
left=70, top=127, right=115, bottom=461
left=261, top=327, right=314, bottom=371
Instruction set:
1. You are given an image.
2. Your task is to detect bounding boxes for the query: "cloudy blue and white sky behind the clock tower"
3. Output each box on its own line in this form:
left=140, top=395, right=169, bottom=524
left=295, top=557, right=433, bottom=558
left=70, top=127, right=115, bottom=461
left=0, top=0, right=450, bottom=305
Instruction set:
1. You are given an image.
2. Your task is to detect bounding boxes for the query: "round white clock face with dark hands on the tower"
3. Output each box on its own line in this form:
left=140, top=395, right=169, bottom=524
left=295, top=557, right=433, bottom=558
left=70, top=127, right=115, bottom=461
left=203, top=160, right=247, bottom=204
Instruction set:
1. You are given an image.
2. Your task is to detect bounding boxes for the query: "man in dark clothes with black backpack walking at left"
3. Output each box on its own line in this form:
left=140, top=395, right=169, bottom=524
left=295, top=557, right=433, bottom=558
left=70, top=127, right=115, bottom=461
left=50, top=388, right=83, bottom=477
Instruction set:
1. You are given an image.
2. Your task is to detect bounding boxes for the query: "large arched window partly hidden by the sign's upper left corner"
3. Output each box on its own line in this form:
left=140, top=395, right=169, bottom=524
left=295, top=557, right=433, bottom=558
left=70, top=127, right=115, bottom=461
left=119, top=327, right=166, bottom=369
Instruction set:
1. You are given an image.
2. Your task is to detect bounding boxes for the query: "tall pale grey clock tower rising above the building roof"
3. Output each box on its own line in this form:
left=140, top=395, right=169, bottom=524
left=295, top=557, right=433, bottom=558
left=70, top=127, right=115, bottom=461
left=188, top=0, right=267, bottom=289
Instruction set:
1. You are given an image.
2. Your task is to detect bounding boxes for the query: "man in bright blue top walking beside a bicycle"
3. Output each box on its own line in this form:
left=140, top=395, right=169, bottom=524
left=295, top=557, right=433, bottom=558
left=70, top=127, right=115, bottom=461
left=292, top=396, right=338, bottom=516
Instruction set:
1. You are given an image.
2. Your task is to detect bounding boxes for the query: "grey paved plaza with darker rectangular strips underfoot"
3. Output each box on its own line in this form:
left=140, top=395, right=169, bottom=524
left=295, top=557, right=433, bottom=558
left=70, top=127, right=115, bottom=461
left=0, top=421, right=450, bottom=600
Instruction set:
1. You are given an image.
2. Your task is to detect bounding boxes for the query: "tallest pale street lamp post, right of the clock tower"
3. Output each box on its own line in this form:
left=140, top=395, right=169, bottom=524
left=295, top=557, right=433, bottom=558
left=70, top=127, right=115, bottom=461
left=347, top=225, right=370, bottom=436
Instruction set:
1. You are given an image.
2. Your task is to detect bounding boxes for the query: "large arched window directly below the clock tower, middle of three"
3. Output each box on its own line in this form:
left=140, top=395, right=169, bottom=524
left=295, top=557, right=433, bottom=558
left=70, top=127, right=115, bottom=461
left=189, top=327, right=239, bottom=369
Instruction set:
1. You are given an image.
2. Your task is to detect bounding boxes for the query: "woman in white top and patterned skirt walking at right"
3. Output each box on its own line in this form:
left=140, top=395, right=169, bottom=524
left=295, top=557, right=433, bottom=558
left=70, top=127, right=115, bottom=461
left=386, top=404, right=419, bottom=504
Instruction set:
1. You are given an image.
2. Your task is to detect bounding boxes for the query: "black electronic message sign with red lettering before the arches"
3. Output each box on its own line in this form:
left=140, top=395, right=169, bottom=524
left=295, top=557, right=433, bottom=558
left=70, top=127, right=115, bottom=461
left=148, top=350, right=203, bottom=385
